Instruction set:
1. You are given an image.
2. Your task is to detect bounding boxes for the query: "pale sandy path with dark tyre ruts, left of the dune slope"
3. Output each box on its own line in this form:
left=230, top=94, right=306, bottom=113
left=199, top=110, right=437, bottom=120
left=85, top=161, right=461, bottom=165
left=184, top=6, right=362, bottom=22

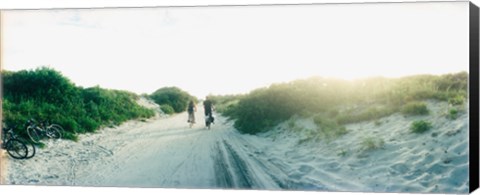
left=2, top=109, right=278, bottom=188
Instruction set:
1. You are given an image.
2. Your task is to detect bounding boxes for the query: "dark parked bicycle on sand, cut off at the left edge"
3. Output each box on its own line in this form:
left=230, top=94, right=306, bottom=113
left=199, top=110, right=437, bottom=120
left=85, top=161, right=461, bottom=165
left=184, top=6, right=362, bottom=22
left=1, top=125, right=35, bottom=159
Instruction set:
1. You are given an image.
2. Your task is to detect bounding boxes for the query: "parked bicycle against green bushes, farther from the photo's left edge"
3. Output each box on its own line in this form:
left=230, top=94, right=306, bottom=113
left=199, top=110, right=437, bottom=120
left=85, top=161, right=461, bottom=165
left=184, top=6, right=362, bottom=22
left=26, top=119, right=63, bottom=143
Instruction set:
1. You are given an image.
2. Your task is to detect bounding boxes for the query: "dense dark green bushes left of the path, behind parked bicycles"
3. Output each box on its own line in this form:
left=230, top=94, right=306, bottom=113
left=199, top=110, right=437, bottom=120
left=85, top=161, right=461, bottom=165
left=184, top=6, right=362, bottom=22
left=2, top=67, right=154, bottom=140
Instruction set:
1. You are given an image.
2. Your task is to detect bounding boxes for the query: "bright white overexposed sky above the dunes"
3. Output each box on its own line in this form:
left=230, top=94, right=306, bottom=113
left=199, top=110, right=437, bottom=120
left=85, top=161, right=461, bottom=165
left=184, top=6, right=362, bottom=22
left=1, top=2, right=469, bottom=98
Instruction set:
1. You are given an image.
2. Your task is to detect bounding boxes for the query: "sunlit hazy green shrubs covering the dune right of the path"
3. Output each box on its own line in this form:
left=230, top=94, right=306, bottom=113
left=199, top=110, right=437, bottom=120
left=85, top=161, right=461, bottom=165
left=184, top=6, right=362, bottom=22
left=212, top=72, right=468, bottom=136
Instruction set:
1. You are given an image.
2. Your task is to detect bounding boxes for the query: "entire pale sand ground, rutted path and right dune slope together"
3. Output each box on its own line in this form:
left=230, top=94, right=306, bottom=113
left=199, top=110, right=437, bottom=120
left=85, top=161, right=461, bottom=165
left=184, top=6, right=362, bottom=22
left=1, top=102, right=468, bottom=193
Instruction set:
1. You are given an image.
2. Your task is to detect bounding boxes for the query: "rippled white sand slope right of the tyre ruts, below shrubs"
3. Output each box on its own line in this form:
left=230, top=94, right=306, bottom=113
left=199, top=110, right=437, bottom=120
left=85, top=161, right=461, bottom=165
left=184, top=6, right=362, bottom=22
left=251, top=102, right=469, bottom=193
